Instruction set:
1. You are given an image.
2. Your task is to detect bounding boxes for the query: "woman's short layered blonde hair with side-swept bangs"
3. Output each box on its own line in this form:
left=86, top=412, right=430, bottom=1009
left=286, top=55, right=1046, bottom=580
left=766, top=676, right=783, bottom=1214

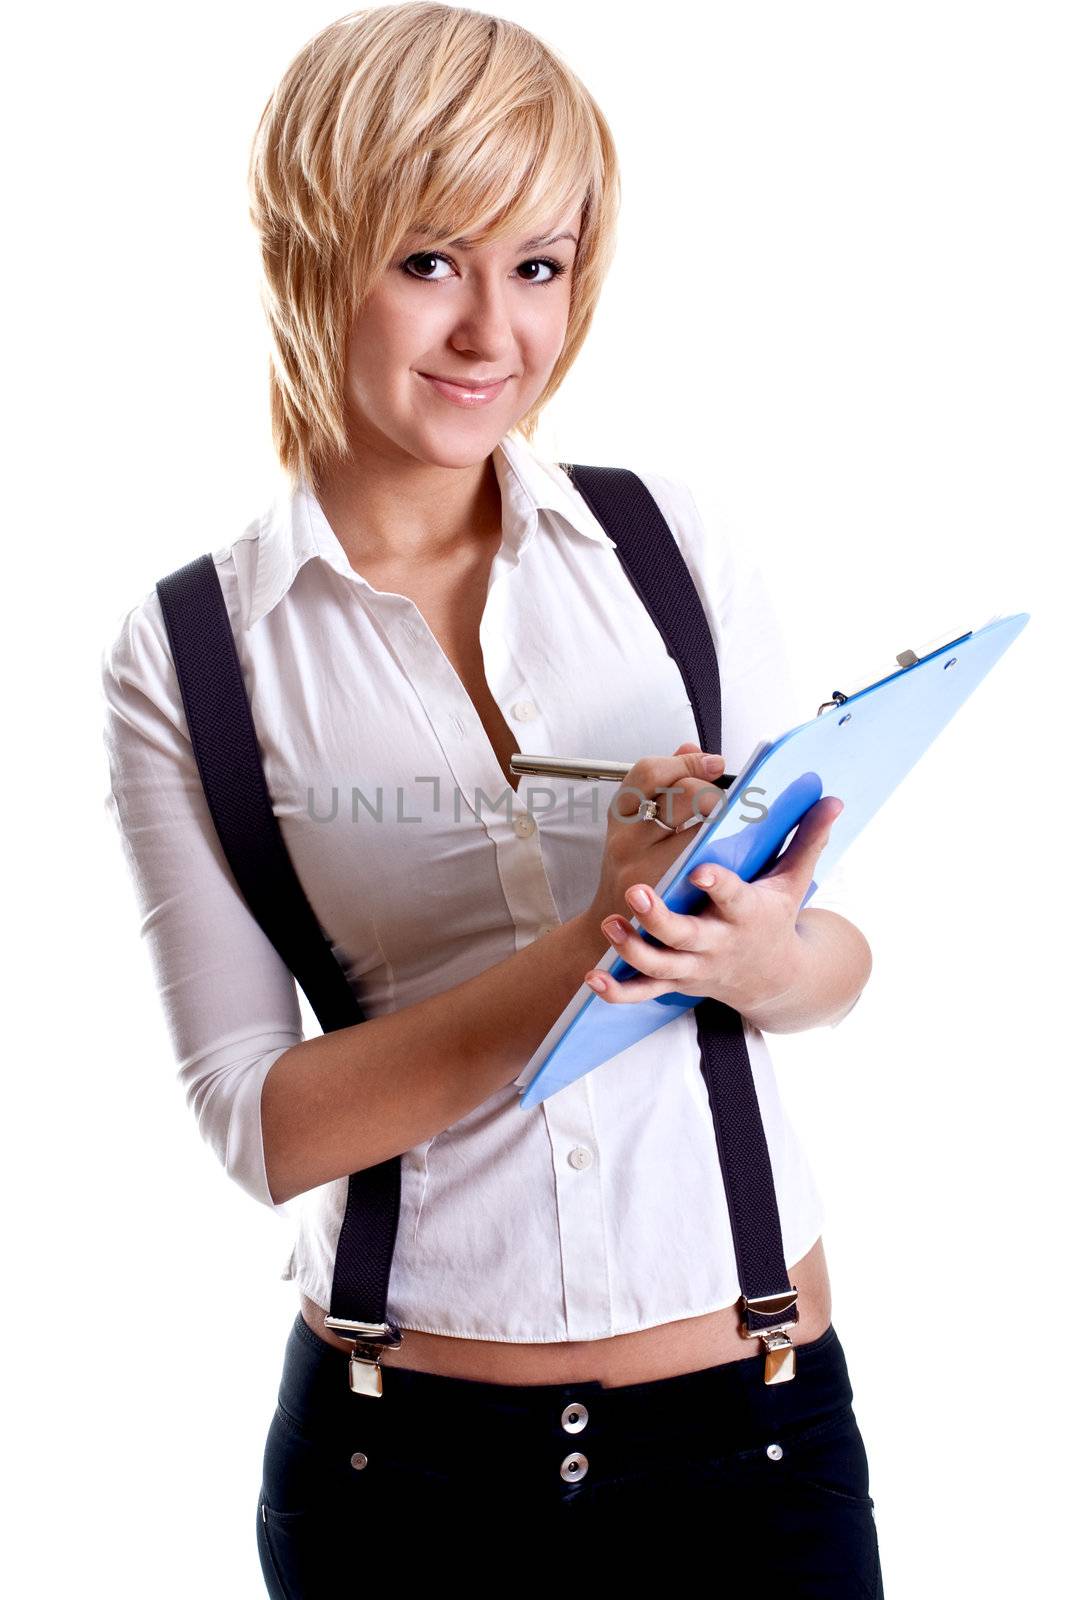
left=248, top=3, right=619, bottom=482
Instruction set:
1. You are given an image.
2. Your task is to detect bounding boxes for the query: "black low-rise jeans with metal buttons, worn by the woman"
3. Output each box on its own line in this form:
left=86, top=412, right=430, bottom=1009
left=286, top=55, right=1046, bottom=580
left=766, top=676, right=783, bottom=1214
left=256, top=1312, right=883, bottom=1600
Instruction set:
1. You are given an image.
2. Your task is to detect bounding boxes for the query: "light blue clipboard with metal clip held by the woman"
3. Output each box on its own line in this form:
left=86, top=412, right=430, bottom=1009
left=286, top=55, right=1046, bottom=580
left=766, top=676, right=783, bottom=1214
left=515, top=611, right=1030, bottom=1109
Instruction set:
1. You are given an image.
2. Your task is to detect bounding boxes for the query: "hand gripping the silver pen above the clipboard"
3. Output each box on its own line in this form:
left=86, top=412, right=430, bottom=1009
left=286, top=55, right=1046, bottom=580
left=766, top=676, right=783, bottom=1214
left=585, top=744, right=726, bottom=925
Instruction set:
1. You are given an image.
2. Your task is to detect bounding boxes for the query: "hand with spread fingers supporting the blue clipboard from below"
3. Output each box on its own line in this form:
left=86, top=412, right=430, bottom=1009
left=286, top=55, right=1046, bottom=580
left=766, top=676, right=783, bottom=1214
left=585, top=795, right=845, bottom=1016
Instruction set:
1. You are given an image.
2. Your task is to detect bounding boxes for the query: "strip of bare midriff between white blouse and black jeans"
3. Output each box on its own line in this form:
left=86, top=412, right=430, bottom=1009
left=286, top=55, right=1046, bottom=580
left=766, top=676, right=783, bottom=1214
left=301, top=1238, right=830, bottom=1389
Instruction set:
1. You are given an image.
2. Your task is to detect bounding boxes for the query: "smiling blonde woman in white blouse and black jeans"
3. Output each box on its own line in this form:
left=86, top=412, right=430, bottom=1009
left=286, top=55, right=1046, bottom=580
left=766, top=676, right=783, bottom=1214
left=104, top=3, right=881, bottom=1597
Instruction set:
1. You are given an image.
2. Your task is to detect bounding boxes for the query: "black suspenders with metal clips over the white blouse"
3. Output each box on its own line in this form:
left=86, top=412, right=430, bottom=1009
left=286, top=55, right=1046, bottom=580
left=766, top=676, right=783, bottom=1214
left=155, top=466, right=798, bottom=1395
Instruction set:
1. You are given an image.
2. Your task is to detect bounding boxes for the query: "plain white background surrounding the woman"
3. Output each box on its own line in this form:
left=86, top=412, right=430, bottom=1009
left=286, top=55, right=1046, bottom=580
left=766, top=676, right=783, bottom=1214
left=3, top=0, right=1067, bottom=1600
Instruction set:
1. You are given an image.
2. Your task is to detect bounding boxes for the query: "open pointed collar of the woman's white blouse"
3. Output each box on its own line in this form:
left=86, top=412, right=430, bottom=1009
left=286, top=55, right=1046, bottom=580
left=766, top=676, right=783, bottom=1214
left=246, top=434, right=614, bottom=627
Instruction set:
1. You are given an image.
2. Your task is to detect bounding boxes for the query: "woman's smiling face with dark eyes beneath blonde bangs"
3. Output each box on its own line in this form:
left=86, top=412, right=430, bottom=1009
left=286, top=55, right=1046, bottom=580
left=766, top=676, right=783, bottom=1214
left=337, top=211, right=581, bottom=467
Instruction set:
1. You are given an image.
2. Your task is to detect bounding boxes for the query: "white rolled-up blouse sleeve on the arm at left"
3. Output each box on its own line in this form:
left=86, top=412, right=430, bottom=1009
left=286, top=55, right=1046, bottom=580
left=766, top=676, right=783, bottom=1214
left=101, top=590, right=304, bottom=1213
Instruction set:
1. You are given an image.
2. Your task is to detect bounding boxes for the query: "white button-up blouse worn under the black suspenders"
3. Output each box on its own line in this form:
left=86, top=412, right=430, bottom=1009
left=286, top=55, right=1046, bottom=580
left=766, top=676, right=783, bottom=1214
left=101, top=435, right=848, bottom=1342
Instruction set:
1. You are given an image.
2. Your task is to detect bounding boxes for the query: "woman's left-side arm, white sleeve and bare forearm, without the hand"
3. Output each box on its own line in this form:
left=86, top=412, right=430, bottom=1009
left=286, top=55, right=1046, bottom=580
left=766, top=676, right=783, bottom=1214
left=101, top=594, right=605, bottom=1208
